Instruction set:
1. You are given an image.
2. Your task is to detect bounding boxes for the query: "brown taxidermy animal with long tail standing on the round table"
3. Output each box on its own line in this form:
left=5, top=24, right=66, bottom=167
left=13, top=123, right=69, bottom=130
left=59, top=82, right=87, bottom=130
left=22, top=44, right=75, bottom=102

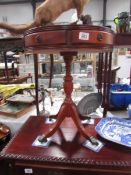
left=0, top=0, right=90, bottom=34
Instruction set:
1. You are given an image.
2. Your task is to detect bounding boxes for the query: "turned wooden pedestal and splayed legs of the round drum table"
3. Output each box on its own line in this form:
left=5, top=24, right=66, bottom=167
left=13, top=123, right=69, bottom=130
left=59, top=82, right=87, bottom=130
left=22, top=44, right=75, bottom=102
left=39, top=52, right=94, bottom=144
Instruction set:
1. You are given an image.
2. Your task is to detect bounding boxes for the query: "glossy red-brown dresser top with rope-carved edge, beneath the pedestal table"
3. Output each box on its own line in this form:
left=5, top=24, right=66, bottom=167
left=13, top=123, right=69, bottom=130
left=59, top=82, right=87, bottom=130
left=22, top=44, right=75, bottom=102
left=1, top=116, right=131, bottom=171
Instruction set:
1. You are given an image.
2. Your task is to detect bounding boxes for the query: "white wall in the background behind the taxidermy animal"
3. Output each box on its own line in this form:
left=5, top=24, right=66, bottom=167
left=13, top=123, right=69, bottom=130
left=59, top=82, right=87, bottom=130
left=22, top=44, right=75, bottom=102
left=0, top=0, right=130, bottom=28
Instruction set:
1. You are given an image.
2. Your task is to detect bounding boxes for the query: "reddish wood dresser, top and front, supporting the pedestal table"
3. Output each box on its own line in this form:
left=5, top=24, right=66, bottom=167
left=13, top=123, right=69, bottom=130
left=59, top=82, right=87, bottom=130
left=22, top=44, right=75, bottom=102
left=1, top=117, right=131, bottom=175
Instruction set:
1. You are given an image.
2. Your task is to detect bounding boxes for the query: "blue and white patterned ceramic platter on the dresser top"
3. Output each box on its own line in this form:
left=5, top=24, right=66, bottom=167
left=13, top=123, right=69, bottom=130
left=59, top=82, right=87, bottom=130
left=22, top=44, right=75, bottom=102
left=95, top=117, right=131, bottom=148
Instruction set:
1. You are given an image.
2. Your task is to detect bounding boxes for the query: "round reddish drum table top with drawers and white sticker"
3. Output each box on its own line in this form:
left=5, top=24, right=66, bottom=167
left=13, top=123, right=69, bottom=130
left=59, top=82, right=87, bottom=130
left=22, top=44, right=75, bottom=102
left=24, top=25, right=114, bottom=53
